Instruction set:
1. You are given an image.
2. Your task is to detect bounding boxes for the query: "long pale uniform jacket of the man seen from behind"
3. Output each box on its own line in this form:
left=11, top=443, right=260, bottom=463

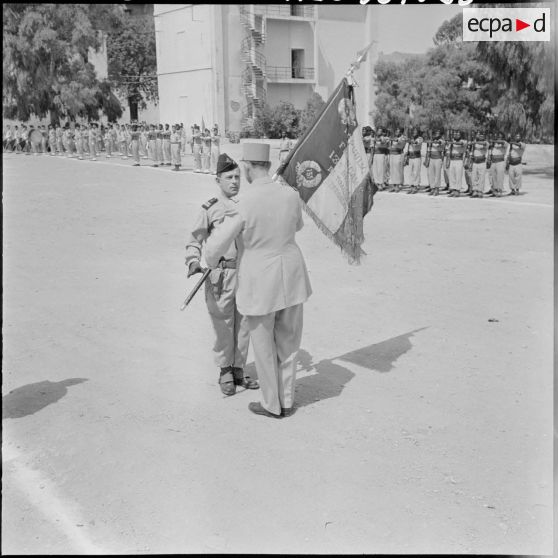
left=205, top=177, right=312, bottom=316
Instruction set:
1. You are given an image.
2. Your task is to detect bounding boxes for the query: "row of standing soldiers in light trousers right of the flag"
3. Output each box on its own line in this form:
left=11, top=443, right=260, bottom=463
left=362, top=126, right=525, bottom=198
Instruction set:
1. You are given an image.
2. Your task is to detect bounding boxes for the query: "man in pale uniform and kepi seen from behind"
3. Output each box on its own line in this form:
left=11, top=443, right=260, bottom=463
left=205, top=143, right=312, bottom=418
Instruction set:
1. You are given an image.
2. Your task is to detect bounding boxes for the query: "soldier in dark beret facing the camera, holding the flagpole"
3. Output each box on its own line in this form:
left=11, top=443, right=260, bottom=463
left=186, top=153, right=259, bottom=395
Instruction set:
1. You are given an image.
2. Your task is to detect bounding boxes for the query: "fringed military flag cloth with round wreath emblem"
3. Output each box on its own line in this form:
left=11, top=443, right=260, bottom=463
left=276, top=78, right=377, bottom=264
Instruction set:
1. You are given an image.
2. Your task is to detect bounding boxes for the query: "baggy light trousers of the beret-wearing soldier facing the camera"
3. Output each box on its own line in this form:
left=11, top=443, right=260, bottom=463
left=206, top=270, right=250, bottom=368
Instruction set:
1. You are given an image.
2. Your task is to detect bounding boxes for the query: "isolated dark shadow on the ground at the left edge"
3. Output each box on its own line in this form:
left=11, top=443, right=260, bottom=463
left=2, top=378, right=87, bottom=419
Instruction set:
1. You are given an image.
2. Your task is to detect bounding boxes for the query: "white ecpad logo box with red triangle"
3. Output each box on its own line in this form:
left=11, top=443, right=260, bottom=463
left=463, top=8, right=551, bottom=41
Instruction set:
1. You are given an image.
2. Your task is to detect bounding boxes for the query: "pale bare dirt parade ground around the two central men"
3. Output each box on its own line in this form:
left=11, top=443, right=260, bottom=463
left=2, top=143, right=554, bottom=554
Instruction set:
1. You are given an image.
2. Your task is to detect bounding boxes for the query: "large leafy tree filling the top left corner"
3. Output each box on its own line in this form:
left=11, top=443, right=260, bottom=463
left=2, top=3, right=122, bottom=123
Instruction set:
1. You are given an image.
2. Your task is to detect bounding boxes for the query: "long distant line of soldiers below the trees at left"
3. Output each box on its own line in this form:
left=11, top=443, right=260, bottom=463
left=3, top=122, right=221, bottom=174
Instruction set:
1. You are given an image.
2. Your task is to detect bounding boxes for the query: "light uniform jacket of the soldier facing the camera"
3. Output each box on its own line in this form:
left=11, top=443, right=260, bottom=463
left=186, top=188, right=238, bottom=267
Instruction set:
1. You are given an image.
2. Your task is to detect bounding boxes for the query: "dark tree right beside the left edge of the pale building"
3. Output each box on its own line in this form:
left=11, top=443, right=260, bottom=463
left=107, top=14, right=158, bottom=120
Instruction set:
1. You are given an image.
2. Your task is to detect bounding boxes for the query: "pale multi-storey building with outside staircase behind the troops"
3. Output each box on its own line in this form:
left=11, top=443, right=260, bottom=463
left=154, top=4, right=377, bottom=132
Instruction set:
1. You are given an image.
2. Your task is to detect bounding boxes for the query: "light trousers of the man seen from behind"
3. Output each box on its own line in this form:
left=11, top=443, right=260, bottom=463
left=246, top=304, right=303, bottom=415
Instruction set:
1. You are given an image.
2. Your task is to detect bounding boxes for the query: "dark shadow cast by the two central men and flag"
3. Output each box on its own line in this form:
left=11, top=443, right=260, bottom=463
left=296, top=328, right=426, bottom=407
